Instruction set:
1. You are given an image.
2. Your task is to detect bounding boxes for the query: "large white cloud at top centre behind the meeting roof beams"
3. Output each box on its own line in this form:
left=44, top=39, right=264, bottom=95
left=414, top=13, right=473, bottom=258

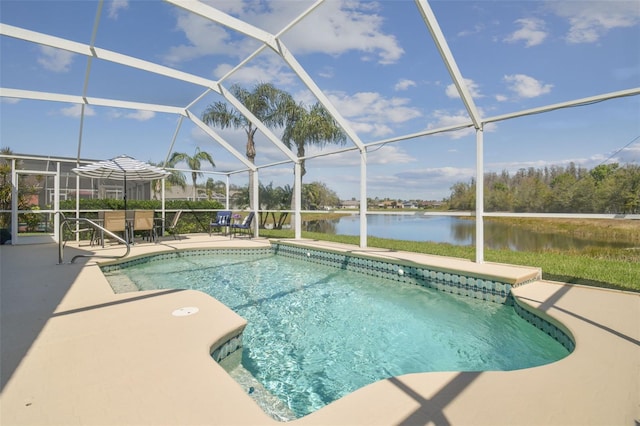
left=164, top=1, right=404, bottom=64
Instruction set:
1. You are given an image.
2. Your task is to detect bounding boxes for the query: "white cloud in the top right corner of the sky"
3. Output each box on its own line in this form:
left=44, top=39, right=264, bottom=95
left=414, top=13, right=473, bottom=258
left=547, top=1, right=640, bottom=43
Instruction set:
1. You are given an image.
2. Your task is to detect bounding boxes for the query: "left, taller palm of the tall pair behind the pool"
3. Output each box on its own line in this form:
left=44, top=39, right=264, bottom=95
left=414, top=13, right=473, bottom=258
left=202, top=83, right=290, bottom=208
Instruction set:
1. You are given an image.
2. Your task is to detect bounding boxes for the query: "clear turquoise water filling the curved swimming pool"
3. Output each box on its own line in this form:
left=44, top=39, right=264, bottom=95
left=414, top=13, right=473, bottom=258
left=106, top=254, right=568, bottom=417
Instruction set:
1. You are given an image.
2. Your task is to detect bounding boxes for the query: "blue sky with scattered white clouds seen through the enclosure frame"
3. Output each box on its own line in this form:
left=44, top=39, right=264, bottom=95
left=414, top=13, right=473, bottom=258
left=0, top=0, right=640, bottom=200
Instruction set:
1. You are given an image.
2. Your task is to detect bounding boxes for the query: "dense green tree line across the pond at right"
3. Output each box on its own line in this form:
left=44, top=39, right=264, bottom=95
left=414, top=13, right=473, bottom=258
left=446, top=163, right=640, bottom=214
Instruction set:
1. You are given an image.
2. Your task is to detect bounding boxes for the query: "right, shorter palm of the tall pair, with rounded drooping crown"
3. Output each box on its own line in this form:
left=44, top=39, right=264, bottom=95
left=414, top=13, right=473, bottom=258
left=282, top=102, right=347, bottom=218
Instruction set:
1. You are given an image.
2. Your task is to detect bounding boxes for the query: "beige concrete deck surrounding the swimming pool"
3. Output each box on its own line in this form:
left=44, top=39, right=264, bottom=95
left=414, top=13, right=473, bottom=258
left=0, top=235, right=640, bottom=425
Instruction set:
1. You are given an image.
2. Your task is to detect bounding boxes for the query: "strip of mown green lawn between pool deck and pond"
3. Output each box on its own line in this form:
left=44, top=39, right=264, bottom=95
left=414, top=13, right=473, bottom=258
left=260, top=229, right=640, bottom=292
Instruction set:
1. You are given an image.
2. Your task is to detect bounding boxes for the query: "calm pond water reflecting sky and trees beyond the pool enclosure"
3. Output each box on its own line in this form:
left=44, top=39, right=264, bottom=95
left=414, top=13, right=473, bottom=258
left=303, top=215, right=629, bottom=251
